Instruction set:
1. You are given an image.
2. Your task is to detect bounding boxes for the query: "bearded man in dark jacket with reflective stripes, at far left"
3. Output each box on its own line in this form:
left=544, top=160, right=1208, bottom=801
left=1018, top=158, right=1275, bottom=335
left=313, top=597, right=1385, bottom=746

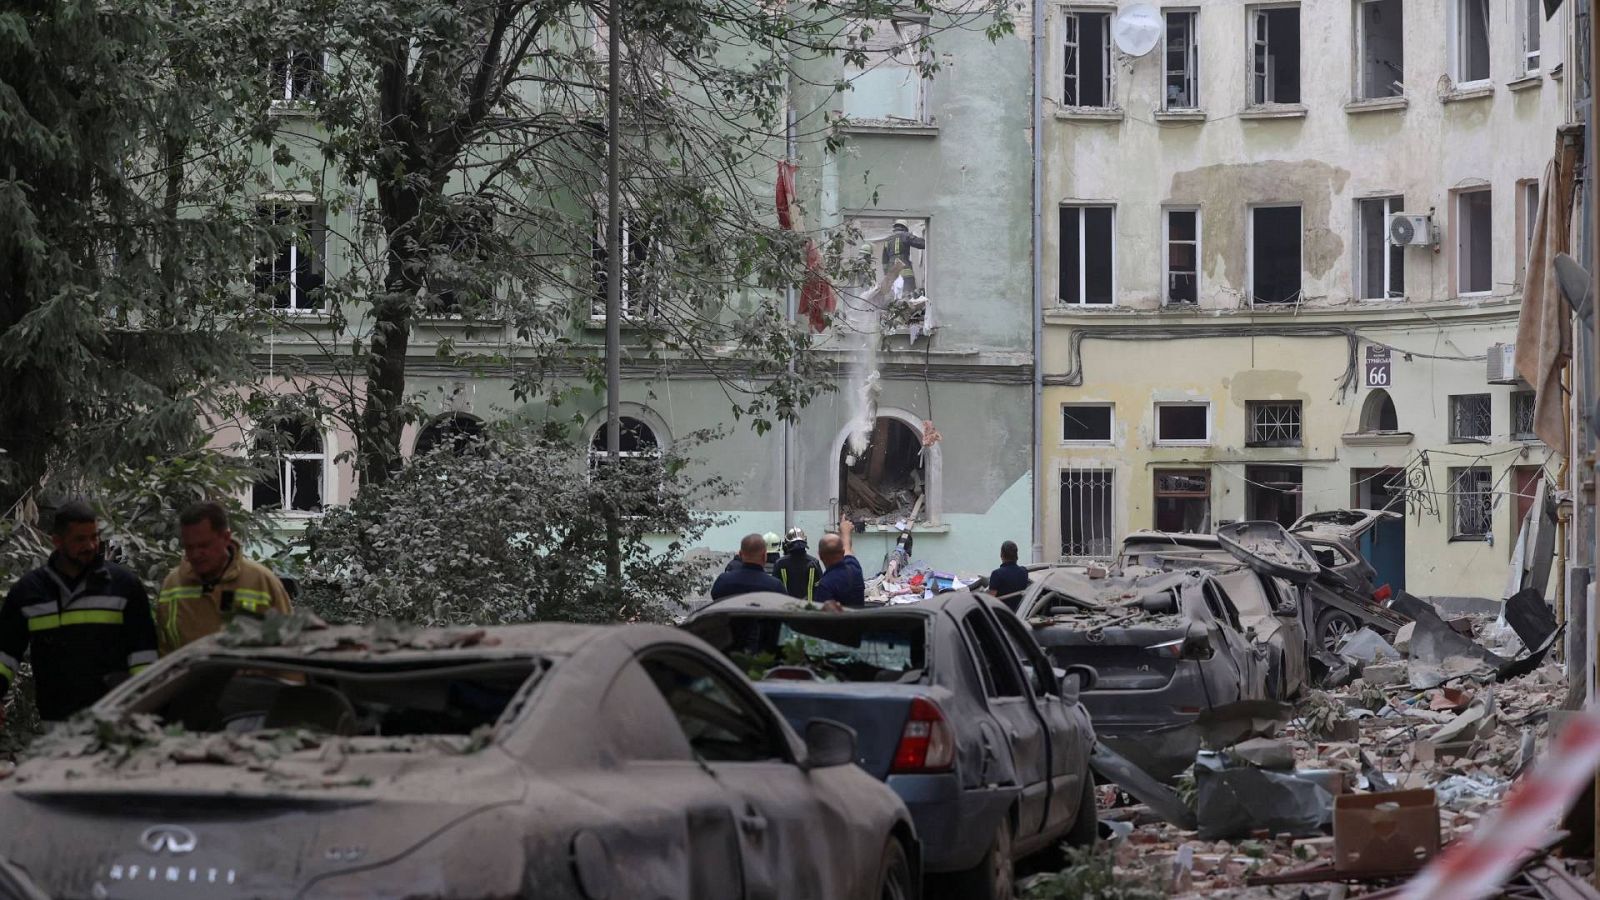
left=0, top=501, right=157, bottom=722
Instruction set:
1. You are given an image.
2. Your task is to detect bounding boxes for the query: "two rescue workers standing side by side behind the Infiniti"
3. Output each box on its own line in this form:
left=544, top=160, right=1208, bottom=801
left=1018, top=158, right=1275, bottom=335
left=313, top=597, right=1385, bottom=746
left=0, top=501, right=290, bottom=722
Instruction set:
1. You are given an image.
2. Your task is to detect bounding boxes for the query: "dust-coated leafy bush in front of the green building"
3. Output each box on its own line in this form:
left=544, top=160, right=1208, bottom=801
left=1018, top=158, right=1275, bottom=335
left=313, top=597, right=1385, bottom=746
left=301, top=431, right=728, bottom=625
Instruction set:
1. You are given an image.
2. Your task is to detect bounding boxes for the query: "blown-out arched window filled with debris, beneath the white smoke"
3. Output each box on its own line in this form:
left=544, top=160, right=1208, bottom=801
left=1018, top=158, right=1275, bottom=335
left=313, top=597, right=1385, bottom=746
left=838, top=416, right=933, bottom=522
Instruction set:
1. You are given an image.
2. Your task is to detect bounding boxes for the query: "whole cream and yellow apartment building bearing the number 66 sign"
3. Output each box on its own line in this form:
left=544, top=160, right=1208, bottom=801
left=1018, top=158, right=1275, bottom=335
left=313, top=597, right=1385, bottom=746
left=1038, top=0, right=1573, bottom=597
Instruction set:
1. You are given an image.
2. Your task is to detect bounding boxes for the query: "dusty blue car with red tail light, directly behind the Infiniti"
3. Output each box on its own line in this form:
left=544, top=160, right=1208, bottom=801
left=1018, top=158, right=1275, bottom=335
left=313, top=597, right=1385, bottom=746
left=683, top=591, right=1098, bottom=900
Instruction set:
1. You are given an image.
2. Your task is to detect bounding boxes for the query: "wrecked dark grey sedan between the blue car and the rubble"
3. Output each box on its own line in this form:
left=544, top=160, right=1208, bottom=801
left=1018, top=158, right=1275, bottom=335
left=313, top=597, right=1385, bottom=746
left=1021, top=567, right=1270, bottom=778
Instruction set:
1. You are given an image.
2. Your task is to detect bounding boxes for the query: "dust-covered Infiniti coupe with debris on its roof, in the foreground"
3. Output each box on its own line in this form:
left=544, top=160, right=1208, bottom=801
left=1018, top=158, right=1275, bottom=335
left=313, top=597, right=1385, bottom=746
left=0, top=620, right=920, bottom=900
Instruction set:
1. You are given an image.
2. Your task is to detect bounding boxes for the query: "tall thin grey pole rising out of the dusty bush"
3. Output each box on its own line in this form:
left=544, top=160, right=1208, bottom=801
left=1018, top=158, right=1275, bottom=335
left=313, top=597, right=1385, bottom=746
left=605, top=0, right=622, bottom=604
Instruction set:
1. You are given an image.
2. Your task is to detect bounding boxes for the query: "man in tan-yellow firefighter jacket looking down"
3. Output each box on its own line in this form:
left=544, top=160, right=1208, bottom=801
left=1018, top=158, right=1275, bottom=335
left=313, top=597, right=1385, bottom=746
left=155, top=503, right=290, bottom=657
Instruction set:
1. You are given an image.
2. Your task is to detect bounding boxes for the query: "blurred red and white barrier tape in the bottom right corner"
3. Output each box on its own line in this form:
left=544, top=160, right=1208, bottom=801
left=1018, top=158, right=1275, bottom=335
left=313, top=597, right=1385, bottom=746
left=1400, top=709, right=1600, bottom=900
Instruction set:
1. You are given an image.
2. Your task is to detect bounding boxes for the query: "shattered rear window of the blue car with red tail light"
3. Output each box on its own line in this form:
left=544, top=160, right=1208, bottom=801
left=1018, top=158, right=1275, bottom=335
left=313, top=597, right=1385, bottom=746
left=698, top=613, right=928, bottom=682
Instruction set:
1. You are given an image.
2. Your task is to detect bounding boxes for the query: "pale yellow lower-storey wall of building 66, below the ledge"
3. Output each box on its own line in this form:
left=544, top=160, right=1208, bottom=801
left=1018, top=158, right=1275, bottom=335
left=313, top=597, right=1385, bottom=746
left=1040, top=317, right=1555, bottom=599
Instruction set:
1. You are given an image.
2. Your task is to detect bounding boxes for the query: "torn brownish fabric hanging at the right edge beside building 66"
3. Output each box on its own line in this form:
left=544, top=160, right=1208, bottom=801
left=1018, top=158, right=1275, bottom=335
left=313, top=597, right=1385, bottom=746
left=1517, top=138, right=1578, bottom=452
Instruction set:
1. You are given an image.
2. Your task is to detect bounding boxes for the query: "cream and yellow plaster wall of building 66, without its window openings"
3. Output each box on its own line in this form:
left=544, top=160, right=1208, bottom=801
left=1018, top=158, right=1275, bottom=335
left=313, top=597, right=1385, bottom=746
left=1038, top=0, right=1570, bottom=597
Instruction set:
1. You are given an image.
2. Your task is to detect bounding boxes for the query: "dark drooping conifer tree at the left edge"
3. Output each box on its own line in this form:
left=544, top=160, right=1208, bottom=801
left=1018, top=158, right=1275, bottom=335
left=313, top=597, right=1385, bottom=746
left=0, top=0, right=272, bottom=517
